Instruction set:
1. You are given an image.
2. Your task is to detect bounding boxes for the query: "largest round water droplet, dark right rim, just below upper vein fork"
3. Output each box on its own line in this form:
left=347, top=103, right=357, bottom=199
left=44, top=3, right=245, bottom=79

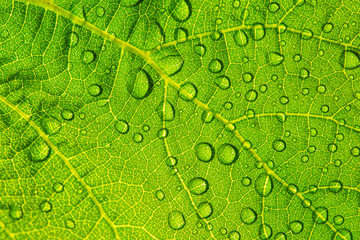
left=126, top=68, right=154, bottom=99
